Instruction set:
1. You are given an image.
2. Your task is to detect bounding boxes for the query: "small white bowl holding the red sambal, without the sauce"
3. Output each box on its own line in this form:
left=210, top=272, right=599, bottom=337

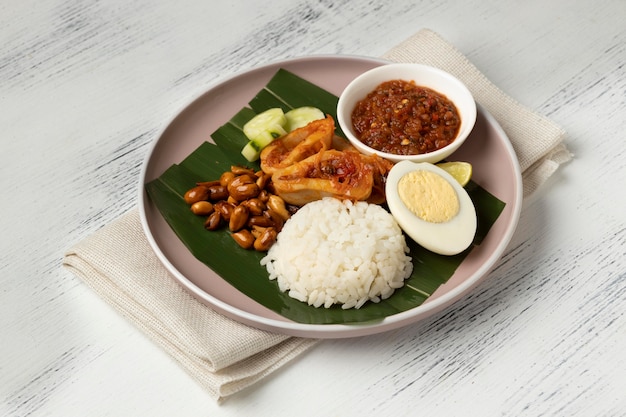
left=337, top=64, right=476, bottom=164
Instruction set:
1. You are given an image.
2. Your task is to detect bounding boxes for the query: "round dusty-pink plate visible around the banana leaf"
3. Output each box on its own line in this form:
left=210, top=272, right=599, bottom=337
left=139, top=56, right=522, bottom=338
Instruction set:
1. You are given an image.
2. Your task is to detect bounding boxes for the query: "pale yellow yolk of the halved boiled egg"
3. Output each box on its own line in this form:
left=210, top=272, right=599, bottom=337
left=398, top=170, right=460, bottom=223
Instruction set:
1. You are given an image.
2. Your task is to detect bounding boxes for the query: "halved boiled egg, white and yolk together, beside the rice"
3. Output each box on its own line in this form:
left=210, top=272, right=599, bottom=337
left=385, top=161, right=477, bottom=255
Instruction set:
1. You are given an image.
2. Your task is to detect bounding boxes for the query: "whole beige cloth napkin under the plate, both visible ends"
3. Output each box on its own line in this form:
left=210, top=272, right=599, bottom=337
left=63, top=30, right=570, bottom=401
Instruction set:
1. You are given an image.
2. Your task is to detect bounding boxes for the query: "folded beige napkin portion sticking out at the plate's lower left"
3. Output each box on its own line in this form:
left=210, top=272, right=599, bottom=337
left=63, top=209, right=316, bottom=400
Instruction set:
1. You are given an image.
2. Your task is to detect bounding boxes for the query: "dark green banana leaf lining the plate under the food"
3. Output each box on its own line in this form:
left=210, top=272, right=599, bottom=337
left=145, top=69, right=505, bottom=324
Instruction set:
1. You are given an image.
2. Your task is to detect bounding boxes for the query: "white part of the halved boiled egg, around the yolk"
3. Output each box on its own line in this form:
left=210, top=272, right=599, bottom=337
left=385, top=161, right=477, bottom=255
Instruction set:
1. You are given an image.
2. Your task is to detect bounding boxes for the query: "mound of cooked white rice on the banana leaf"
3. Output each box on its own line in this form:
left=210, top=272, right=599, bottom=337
left=261, top=197, right=413, bottom=309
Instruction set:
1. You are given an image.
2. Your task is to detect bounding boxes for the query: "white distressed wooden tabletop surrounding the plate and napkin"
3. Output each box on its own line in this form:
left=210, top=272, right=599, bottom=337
left=0, top=0, right=626, bottom=416
